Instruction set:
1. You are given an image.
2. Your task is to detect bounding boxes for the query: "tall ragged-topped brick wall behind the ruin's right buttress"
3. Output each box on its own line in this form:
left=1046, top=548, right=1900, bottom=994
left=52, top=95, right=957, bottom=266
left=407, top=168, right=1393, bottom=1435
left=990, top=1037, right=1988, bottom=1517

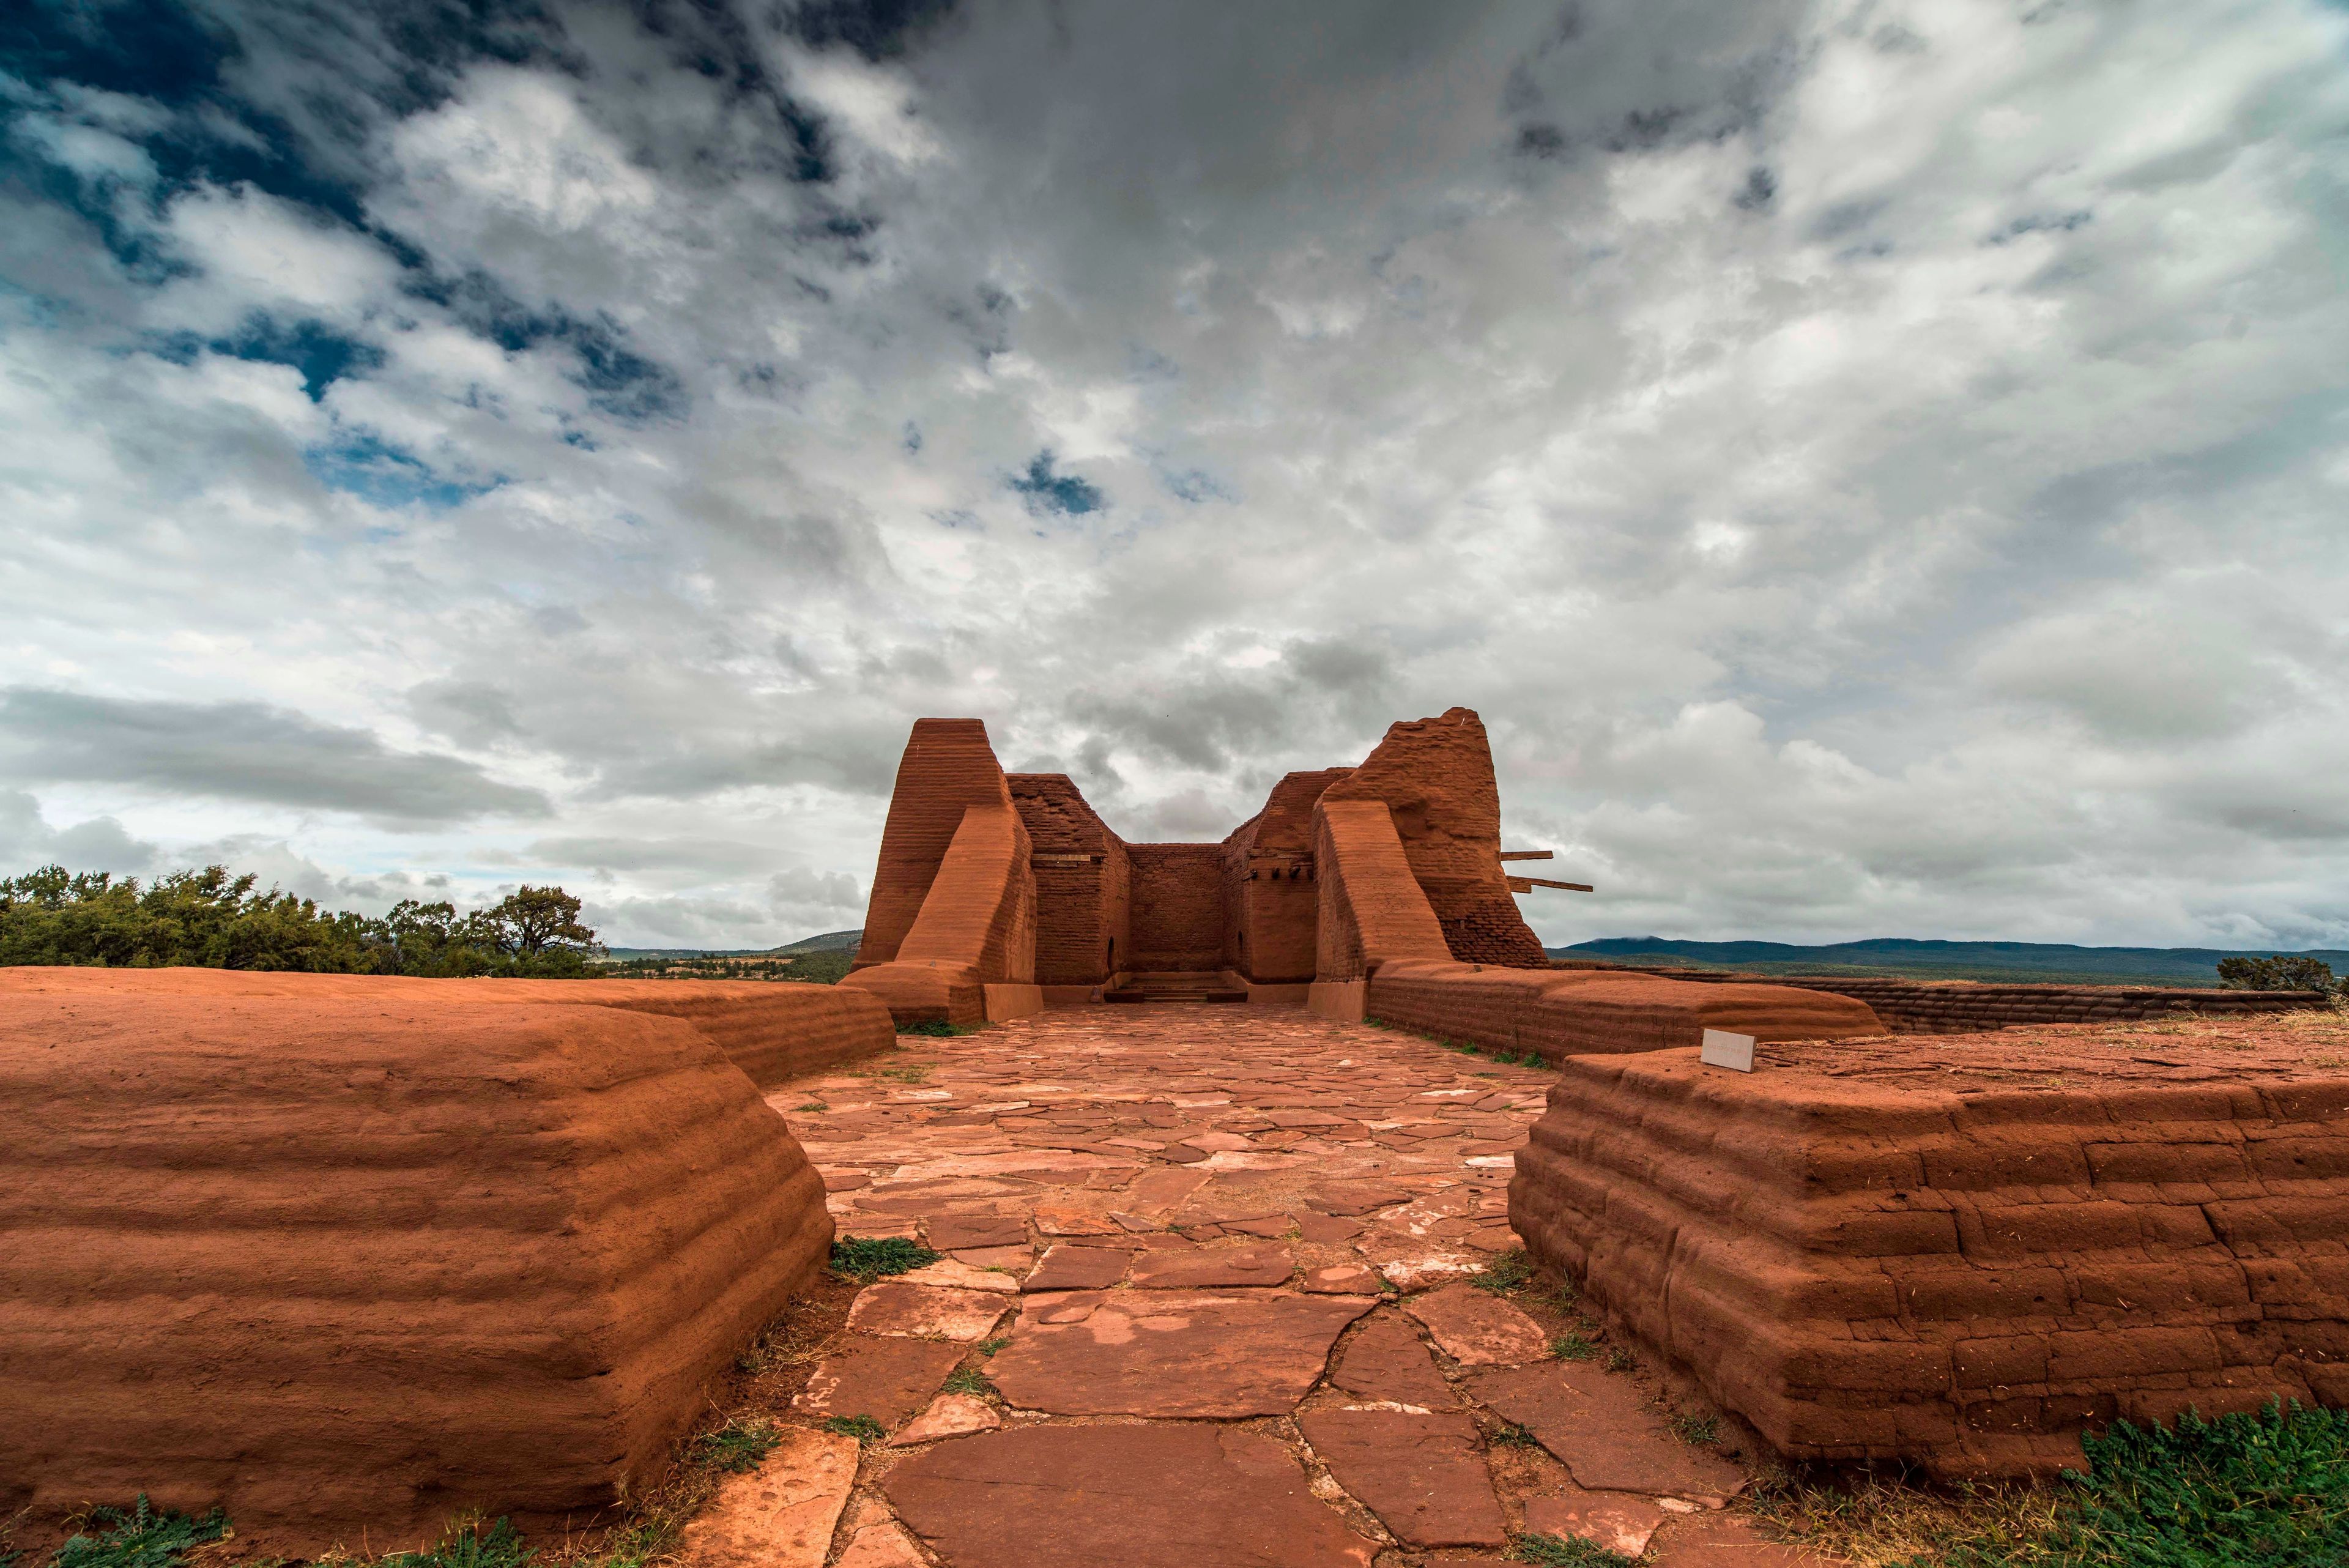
left=1323, top=708, right=1550, bottom=968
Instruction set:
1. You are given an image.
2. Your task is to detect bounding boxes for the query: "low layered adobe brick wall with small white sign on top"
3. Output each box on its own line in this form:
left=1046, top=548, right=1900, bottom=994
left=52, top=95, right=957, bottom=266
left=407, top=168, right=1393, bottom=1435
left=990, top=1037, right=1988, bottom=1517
left=1510, top=1020, right=2349, bottom=1476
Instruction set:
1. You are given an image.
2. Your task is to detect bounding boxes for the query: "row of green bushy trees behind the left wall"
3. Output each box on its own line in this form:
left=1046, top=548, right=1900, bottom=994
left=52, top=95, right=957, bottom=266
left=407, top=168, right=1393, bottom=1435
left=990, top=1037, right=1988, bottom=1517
left=0, top=865, right=604, bottom=980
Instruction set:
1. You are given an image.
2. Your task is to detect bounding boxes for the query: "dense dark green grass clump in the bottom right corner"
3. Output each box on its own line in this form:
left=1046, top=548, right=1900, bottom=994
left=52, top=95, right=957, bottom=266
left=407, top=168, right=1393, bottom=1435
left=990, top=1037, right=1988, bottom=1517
left=1912, top=1403, right=2349, bottom=1568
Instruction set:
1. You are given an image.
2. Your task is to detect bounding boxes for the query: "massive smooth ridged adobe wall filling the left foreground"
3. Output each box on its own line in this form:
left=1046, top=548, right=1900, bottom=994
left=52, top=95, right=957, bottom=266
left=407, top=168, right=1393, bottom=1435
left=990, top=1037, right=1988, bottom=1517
left=0, top=968, right=831, bottom=1556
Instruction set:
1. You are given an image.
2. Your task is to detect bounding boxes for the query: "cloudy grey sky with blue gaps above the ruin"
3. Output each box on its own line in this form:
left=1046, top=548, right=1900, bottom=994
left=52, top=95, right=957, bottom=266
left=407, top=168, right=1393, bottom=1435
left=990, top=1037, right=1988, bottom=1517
left=0, top=0, right=2349, bottom=945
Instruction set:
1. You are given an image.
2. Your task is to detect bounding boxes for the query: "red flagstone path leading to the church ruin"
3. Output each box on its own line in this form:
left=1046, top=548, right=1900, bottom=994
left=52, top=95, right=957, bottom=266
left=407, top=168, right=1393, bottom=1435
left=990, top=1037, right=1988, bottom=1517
left=686, top=1006, right=1825, bottom=1568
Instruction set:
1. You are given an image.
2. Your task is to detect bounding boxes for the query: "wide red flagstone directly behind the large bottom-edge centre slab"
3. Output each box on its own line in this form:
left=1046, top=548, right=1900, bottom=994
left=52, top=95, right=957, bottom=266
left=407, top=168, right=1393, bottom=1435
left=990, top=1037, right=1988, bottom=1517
left=989, top=1291, right=1372, bottom=1420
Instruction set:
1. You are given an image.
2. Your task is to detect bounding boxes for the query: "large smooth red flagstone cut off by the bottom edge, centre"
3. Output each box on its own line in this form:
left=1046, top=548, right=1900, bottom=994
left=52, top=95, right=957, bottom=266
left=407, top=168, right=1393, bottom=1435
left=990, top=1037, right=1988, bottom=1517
left=883, top=1425, right=1376, bottom=1568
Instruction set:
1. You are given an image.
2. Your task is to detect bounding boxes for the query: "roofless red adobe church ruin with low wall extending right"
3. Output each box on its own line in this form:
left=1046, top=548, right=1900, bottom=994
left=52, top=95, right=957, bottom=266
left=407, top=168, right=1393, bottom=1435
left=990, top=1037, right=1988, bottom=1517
left=845, top=708, right=1882, bottom=1060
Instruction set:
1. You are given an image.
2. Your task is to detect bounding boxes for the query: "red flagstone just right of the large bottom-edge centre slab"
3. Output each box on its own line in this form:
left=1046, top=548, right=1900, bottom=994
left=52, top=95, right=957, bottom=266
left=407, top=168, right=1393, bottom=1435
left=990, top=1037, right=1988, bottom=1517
left=1297, top=1411, right=1508, bottom=1547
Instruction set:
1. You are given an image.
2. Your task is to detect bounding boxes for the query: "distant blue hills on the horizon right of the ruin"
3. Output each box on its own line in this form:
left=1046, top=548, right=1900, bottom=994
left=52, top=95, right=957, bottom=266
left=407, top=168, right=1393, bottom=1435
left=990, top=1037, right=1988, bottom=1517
left=1548, top=935, right=2349, bottom=985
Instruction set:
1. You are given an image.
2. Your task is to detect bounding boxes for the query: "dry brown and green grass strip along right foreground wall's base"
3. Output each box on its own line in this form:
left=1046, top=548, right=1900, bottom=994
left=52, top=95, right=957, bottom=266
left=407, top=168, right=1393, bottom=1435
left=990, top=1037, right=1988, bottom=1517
left=1754, top=1403, right=2349, bottom=1568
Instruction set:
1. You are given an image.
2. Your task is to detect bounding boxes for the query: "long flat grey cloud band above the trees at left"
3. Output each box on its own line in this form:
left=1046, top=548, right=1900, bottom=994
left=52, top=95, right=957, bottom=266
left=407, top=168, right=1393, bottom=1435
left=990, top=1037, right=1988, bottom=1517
left=0, top=686, right=550, bottom=825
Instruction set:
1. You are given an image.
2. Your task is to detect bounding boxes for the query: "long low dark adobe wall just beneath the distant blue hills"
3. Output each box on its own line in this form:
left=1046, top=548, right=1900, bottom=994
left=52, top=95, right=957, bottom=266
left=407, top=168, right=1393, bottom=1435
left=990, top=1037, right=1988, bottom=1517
left=1630, top=968, right=2323, bottom=1035
